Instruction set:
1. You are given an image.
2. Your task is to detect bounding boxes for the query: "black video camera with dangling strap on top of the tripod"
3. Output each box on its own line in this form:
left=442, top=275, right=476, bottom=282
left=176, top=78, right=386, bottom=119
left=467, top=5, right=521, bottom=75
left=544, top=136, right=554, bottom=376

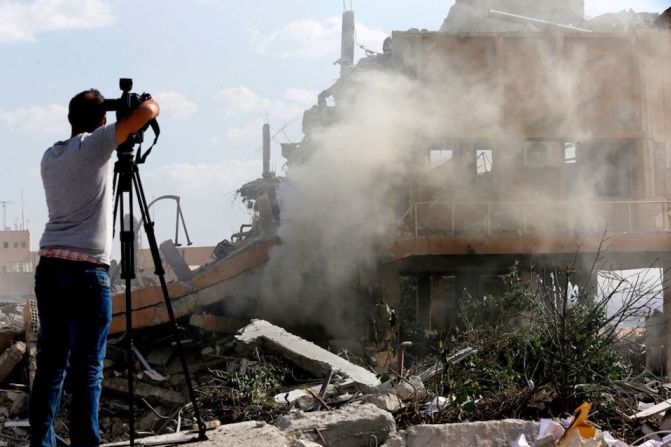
left=103, top=78, right=161, bottom=163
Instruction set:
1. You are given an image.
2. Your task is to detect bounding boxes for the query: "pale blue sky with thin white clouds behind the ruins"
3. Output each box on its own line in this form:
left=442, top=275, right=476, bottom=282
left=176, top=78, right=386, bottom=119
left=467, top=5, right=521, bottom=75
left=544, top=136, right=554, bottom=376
left=0, top=0, right=670, bottom=258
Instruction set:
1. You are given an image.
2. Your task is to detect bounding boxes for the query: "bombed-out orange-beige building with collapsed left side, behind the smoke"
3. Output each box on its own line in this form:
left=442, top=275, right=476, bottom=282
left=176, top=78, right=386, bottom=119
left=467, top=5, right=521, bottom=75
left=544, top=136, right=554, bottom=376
left=102, top=0, right=671, bottom=354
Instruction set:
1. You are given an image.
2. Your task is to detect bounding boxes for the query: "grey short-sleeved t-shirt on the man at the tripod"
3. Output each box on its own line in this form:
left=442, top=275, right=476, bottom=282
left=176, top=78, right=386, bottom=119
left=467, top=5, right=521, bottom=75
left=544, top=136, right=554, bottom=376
left=40, top=124, right=116, bottom=265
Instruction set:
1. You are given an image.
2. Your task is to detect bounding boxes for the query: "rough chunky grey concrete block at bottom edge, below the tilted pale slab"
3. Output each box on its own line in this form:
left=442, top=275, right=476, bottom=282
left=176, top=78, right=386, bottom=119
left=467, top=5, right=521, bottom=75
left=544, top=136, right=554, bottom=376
left=273, top=404, right=396, bottom=447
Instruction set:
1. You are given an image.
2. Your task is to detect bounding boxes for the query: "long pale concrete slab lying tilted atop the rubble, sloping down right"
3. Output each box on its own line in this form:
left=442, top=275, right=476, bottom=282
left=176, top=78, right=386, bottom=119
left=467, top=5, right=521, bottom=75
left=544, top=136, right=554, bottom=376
left=235, top=320, right=380, bottom=386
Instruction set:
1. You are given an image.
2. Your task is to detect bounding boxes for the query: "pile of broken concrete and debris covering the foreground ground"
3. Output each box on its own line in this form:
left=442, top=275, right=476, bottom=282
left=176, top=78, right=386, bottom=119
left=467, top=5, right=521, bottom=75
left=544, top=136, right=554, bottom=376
left=0, top=306, right=671, bottom=447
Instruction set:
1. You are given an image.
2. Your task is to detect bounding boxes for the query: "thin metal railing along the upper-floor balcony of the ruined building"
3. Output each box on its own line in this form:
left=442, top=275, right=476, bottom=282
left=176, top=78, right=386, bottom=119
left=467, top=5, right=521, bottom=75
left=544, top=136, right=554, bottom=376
left=402, top=201, right=671, bottom=237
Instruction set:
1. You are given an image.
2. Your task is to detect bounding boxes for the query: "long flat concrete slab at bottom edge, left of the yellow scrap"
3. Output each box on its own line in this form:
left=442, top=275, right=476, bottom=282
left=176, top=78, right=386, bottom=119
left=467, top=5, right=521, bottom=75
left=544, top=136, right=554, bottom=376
left=405, top=419, right=539, bottom=447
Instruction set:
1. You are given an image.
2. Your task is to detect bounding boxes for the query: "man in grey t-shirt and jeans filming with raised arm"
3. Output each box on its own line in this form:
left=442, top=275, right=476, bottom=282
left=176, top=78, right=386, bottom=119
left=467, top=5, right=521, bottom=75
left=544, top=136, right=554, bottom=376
left=29, top=89, right=159, bottom=447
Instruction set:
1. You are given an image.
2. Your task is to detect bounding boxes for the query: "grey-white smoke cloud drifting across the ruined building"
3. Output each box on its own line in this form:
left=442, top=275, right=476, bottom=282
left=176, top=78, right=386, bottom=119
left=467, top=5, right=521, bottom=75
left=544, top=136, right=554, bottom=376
left=253, top=12, right=668, bottom=336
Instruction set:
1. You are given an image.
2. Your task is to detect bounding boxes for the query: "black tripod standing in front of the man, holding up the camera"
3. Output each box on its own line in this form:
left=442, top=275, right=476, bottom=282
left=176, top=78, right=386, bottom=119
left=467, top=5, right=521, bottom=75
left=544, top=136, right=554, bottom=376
left=114, top=139, right=207, bottom=447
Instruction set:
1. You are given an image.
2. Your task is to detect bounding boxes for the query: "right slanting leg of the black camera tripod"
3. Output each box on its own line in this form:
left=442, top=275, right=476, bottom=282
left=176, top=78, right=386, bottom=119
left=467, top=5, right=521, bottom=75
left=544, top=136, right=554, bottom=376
left=133, top=170, right=207, bottom=440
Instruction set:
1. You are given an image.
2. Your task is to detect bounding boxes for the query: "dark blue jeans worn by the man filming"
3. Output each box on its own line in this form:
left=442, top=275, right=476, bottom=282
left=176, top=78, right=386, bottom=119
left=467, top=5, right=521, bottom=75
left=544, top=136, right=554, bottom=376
left=29, top=258, right=112, bottom=447
